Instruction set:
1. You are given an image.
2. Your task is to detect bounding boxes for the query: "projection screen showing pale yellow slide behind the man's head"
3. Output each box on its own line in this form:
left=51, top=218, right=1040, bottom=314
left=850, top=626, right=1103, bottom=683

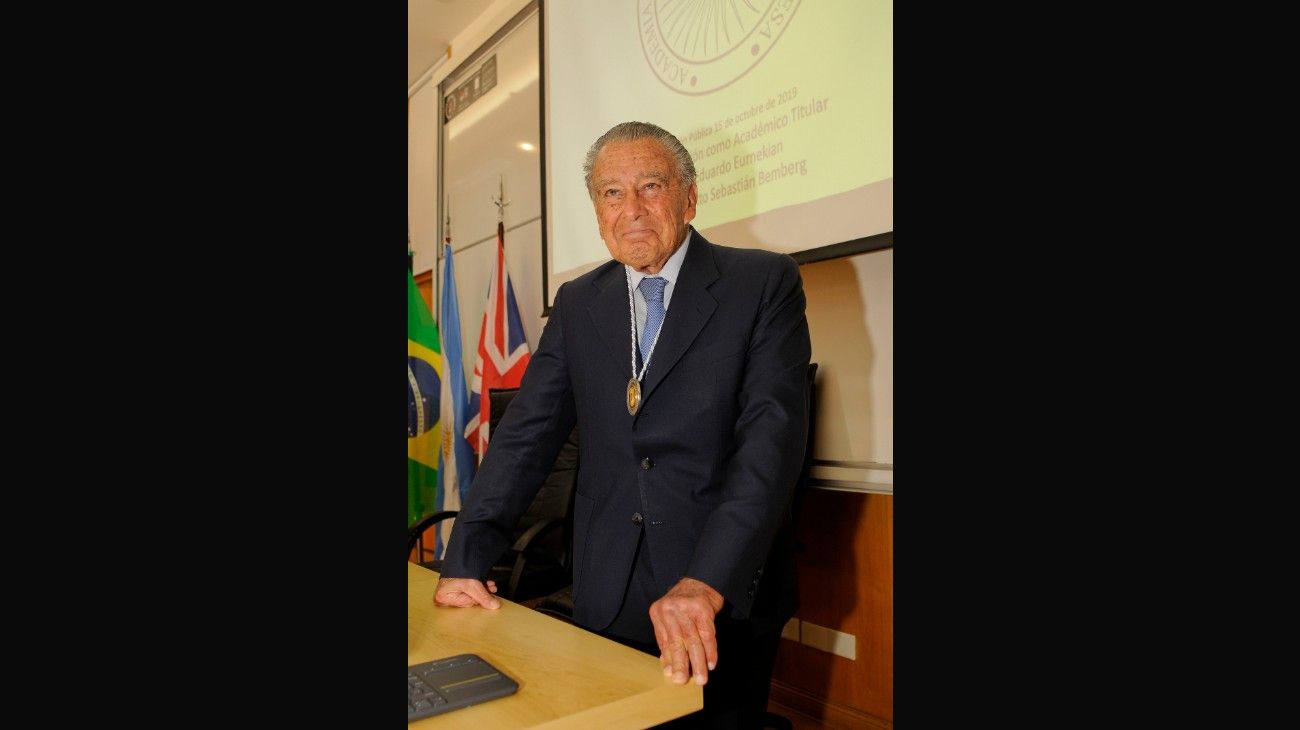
left=542, top=0, right=893, bottom=308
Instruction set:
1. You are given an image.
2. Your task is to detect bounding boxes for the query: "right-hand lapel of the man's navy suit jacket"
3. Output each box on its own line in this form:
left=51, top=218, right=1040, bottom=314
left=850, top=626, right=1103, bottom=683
left=642, top=231, right=718, bottom=399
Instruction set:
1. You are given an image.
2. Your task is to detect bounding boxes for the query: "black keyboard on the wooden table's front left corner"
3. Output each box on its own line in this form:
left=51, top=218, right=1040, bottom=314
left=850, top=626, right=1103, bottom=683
left=407, top=653, right=519, bottom=722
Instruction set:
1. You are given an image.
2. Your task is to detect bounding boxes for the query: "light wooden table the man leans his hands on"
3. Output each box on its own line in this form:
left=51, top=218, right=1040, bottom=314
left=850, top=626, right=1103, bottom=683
left=407, top=562, right=705, bottom=730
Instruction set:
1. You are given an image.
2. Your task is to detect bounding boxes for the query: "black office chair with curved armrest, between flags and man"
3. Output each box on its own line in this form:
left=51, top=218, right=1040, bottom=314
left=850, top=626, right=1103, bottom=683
left=407, top=388, right=577, bottom=603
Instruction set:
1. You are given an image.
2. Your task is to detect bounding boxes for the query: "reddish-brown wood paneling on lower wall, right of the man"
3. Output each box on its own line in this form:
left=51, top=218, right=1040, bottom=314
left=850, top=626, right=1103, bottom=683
left=772, top=490, right=893, bottom=727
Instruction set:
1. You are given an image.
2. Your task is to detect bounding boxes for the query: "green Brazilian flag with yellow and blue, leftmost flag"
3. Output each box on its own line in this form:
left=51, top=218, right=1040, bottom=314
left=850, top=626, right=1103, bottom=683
left=407, top=269, right=442, bottom=527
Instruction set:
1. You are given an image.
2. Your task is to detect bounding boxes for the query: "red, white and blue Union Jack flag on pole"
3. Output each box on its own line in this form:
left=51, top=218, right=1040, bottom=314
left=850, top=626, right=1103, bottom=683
left=465, top=222, right=532, bottom=464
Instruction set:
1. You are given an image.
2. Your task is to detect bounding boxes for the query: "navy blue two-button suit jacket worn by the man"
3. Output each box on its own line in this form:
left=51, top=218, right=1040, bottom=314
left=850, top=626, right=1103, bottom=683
left=442, top=230, right=811, bottom=629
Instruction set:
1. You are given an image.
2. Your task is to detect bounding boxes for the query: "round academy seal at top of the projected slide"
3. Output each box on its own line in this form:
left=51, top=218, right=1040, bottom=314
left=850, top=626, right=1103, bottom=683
left=637, top=0, right=801, bottom=96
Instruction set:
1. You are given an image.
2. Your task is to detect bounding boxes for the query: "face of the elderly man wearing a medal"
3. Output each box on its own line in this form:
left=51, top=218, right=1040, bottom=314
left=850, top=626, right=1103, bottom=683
left=592, top=139, right=696, bottom=274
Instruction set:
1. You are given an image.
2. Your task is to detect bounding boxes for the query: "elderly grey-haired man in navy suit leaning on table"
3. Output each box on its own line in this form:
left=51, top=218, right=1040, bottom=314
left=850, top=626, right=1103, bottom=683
left=434, top=122, right=810, bottom=727
